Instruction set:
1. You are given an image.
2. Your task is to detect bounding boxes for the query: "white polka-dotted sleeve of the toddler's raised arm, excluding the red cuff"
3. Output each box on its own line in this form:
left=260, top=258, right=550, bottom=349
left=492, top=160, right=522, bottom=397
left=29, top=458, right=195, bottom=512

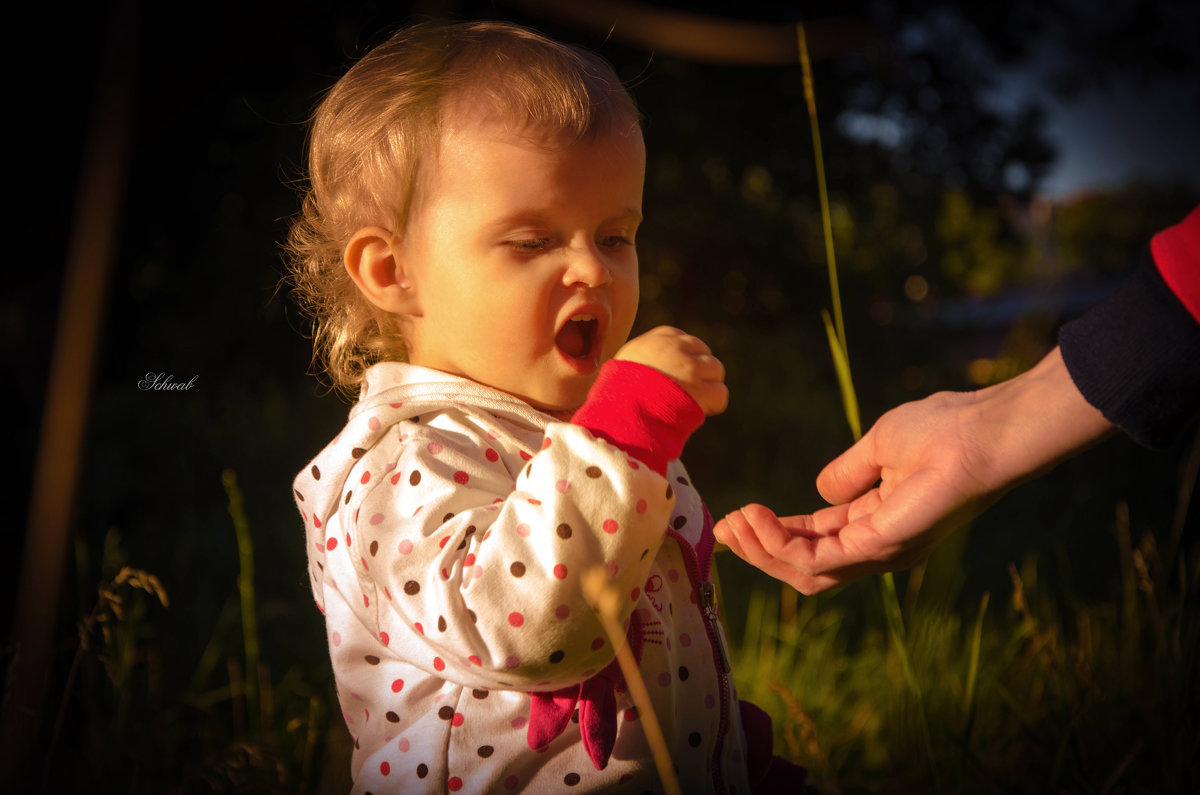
left=338, top=408, right=674, bottom=691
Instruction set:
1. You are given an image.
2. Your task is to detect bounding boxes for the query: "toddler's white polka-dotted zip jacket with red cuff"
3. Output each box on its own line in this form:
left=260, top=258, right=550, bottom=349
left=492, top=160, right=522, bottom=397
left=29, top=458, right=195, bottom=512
left=295, top=361, right=770, bottom=795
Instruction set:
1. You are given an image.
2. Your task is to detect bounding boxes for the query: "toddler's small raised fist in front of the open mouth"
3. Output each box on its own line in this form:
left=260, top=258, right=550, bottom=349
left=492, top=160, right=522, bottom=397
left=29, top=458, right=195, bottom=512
left=613, top=325, right=730, bottom=417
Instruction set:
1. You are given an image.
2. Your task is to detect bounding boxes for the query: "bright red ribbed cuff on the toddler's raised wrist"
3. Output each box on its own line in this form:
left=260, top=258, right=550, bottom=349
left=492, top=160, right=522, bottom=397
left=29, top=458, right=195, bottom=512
left=571, top=359, right=704, bottom=476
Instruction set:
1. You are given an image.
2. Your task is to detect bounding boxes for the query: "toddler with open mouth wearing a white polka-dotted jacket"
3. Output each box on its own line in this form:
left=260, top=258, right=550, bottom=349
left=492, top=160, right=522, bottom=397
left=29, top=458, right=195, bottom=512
left=290, top=23, right=801, bottom=794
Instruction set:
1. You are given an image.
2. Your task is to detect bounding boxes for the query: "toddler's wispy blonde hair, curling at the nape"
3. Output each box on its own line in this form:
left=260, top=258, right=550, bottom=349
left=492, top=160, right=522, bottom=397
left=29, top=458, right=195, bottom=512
left=286, top=22, right=640, bottom=396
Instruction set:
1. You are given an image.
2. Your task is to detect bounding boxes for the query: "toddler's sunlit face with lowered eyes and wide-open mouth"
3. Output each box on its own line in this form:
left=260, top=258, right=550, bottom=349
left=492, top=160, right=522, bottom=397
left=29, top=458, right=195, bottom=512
left=397, top=120, right=646, bottom=413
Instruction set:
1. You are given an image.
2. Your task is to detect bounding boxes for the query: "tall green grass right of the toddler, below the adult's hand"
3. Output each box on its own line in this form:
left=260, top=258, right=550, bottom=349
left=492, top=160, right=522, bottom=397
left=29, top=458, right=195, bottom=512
left=720, top=492, right=1200, bottom=794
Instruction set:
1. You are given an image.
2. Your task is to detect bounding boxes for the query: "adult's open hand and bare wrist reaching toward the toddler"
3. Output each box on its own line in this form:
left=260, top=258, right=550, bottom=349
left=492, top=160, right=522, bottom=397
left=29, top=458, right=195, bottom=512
left=715, top=348, right=1112, bottom=593
